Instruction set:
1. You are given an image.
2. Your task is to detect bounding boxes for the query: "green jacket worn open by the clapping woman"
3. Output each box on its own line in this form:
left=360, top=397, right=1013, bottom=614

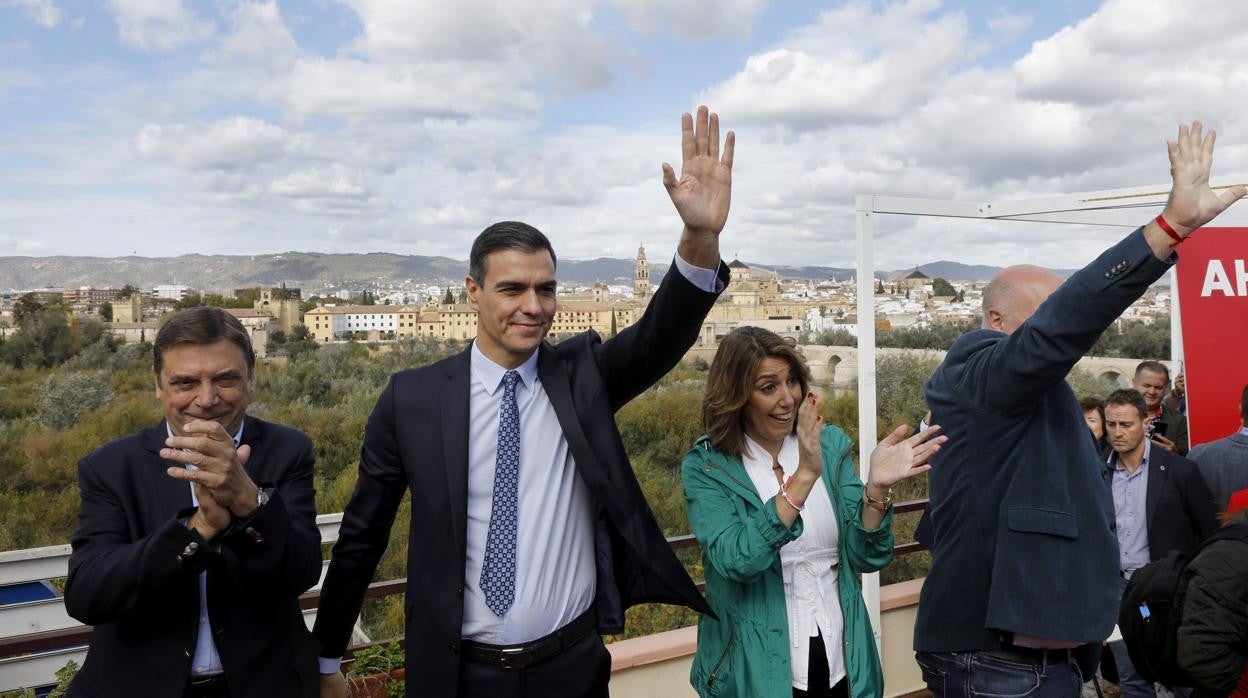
left=680, top=425, right=892, bottom=698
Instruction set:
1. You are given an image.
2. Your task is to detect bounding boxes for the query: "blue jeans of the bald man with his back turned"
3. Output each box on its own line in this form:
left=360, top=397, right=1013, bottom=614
left=915, top=652, right=1083, bottom=698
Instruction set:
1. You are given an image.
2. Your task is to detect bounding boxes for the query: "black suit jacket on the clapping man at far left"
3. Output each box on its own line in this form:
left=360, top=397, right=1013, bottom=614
left=65, top=417, right=321, bottom=698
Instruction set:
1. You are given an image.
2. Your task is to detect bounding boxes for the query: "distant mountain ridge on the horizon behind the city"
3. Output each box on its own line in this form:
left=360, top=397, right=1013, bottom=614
left=0, top=252, right=1093, bottom=293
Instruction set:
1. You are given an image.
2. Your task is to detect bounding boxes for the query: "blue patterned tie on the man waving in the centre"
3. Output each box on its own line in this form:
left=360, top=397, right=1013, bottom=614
left=480, top=371, right=520, bottom=616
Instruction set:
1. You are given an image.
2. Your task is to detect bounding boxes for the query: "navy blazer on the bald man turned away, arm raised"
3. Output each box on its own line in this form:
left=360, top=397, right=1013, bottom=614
left=915, top=230, right=1176, bottom=652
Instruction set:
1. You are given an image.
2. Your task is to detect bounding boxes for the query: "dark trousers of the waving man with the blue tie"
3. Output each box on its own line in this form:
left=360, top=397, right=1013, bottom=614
left=459, top=632, right=612, bottom=698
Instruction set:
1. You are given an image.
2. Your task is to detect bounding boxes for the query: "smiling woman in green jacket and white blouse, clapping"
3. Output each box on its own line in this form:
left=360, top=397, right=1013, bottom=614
left=681, top=327, right=945, bottom=698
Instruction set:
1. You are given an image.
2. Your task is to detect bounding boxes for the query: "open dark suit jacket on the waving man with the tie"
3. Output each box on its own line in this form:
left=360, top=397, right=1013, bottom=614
left=314, top=265, right=728, bottom=696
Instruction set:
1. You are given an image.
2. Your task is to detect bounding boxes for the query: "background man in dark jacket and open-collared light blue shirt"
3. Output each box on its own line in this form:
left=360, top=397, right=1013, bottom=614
left=1104, top=390, right=1218, bottom=698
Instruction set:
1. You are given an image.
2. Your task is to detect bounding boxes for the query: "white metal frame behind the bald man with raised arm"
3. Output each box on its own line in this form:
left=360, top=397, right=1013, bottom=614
left=854, top=177, right=1246, bottom=646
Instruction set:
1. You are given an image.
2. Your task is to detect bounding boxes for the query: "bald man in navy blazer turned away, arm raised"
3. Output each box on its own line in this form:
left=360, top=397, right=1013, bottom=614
left=915, top=122, right=1246, bottom=696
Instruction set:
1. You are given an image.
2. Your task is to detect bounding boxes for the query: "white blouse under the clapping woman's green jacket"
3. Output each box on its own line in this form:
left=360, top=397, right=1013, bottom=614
left=741, top=435, right=845, bottom=691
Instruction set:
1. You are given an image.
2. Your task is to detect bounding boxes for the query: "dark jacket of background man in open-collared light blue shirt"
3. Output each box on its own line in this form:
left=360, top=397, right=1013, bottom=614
left=1106, top=443, right=1218, bottom=562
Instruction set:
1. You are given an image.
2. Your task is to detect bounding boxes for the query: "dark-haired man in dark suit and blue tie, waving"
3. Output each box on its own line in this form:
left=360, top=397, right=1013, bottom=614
left=314, top=107, right=734, bottom=698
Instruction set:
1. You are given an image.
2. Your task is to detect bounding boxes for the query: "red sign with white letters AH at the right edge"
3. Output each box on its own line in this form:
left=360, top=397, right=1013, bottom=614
left=1178, top=227, right=1248, bottom=446
